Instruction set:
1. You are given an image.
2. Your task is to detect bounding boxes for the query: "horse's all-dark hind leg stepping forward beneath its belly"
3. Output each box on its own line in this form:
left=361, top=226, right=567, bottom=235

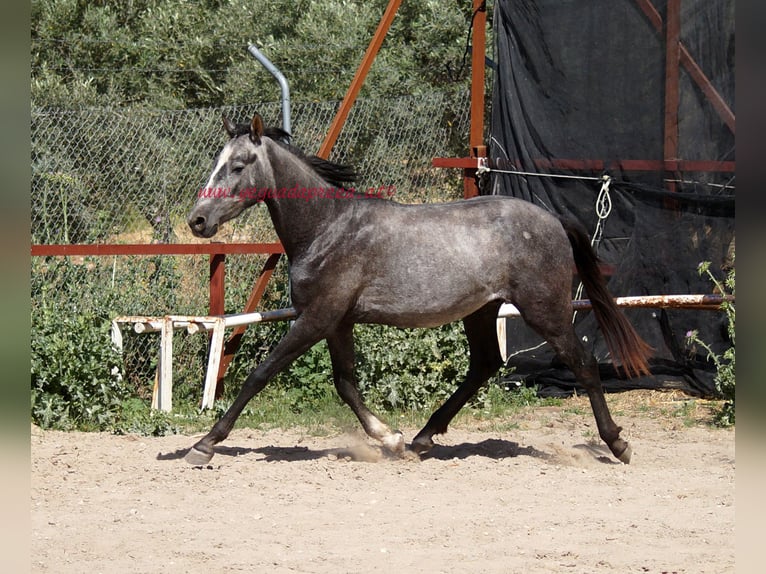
left=410, top=303, right=503, bottom=454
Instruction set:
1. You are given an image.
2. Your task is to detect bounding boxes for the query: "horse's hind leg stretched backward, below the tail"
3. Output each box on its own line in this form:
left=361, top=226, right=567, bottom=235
left=518, top=297, right=632, bottom=464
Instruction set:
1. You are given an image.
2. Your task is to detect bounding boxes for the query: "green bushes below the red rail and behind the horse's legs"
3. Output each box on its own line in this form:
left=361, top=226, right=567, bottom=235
left=31, top=257, right=534, bottom=435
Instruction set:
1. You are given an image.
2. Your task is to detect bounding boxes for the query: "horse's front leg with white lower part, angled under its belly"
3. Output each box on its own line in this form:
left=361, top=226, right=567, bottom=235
left=327, top=323, right=404, bottom=454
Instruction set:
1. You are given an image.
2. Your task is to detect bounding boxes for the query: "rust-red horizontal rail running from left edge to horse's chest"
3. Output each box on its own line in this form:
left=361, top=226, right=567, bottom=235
left=32, top=242, right=285, bottom=257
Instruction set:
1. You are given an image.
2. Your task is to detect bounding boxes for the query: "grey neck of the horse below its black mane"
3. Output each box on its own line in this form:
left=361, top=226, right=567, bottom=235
left=265, top=144, right=350, bottom=258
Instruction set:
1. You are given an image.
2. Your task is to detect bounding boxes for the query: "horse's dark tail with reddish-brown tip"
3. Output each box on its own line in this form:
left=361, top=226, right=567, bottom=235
left=561, top=218, right=652, bottom=377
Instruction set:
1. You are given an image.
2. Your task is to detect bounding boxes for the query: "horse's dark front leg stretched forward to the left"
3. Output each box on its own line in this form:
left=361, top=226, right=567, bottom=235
left=184, top=316, right=323, bottom=465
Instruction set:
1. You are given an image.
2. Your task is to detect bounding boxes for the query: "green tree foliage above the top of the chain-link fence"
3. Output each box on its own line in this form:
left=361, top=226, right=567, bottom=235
left=31, top=0, right=471, bottom=109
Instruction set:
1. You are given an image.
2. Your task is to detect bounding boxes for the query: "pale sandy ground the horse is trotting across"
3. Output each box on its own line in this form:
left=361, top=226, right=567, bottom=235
left=31, top=391, right=735, bottom=574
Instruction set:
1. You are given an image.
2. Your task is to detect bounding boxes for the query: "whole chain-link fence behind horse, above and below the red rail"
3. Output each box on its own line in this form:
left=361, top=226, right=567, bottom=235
left=31, top=91, right=470, bottom=402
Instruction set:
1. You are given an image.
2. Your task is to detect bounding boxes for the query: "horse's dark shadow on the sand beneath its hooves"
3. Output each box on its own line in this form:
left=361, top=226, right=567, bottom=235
left=157, top=439, right=553, bottom=462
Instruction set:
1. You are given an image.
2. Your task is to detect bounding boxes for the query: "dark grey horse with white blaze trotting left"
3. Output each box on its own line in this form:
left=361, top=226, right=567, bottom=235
left=185, top=113, right=651, bottom=465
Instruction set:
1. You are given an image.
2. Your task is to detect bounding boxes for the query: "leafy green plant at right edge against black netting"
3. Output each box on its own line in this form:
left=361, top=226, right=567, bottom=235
left=686, top=258, right=736, bottom=426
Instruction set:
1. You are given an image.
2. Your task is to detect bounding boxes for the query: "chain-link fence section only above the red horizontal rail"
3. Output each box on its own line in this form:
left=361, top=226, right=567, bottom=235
left=31, top=92, right=469, bottom=244
